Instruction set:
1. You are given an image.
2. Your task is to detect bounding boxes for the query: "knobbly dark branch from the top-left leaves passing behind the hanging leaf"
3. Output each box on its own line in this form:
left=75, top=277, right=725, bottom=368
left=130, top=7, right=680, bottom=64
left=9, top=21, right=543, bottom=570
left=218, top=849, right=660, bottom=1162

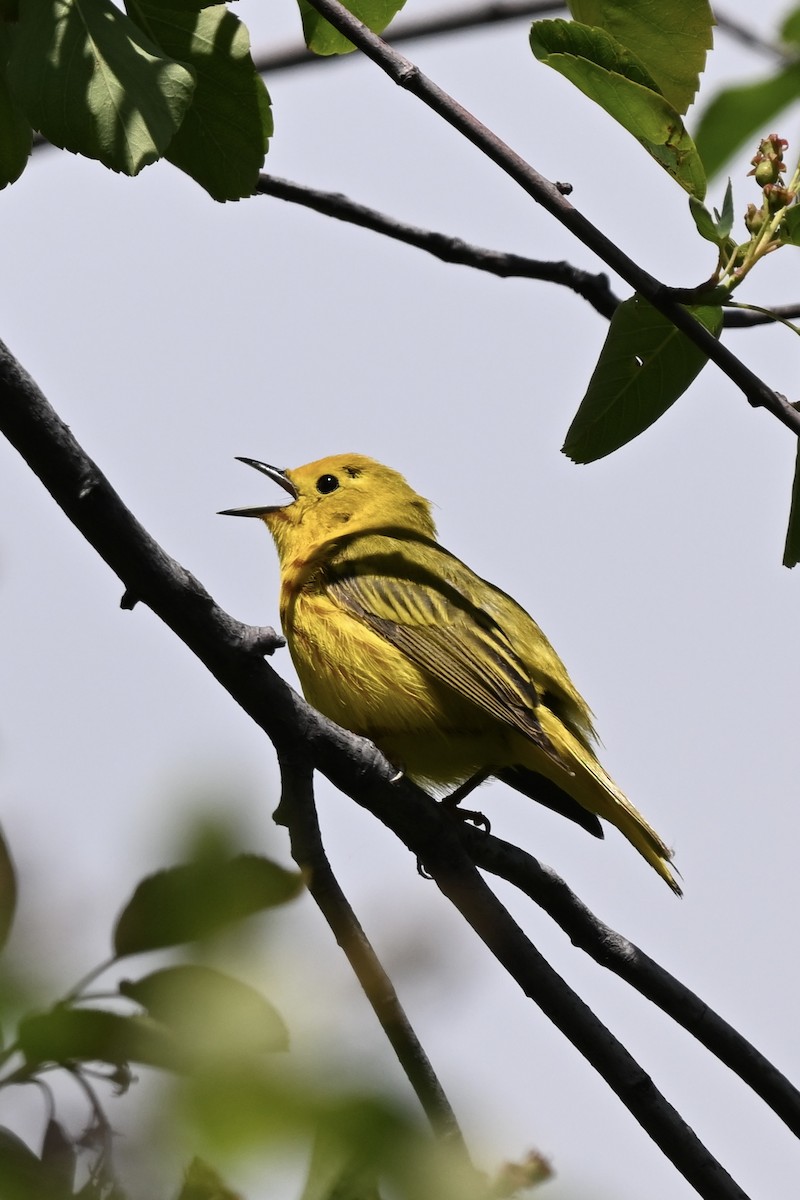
left=255, top=174, right=800, bottom=329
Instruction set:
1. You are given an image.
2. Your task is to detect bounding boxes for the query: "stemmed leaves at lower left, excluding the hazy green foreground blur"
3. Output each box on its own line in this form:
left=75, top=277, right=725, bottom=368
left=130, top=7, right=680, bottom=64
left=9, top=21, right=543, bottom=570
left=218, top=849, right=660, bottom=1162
left=0, top=839, right=297, bottom=1200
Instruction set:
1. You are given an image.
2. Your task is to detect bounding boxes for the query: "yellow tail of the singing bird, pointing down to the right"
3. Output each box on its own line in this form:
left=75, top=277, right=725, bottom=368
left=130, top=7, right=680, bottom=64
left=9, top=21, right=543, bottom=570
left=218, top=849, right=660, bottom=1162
left=527, top=707, right=682, bottom=895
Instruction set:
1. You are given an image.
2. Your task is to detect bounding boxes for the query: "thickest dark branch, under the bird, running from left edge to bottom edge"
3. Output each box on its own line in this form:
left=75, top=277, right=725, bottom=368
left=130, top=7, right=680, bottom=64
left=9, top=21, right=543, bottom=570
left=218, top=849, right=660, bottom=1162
left=0, top=343, right=746, bottom=1200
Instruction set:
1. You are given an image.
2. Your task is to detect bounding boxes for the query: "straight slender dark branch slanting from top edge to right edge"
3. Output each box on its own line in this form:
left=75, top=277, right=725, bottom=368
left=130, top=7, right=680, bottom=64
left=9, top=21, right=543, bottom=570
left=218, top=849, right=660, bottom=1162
left=297, top=0, right=800, bottom=434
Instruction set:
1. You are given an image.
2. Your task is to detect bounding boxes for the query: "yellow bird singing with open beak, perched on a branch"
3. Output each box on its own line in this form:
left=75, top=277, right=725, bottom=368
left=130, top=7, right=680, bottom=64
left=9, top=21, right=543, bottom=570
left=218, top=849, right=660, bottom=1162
left=224, top=454, right=680, bottom=895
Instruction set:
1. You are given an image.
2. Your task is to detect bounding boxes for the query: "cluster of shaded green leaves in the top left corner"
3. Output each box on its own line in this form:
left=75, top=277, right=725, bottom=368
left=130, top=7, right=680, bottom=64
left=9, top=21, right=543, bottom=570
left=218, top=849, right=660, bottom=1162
left=0, top=0, right=272, bottom=200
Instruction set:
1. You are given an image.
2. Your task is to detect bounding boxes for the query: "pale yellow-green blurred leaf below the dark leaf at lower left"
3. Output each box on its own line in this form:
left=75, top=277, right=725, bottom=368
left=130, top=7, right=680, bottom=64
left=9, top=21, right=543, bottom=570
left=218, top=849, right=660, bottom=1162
left=120, top=965, right=289, bottom=1056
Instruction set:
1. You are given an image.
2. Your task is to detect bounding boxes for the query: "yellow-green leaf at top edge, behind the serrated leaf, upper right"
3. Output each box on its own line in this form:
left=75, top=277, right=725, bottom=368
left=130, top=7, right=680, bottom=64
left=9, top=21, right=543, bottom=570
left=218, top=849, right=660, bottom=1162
left=570, top=0, right=715, bottom=113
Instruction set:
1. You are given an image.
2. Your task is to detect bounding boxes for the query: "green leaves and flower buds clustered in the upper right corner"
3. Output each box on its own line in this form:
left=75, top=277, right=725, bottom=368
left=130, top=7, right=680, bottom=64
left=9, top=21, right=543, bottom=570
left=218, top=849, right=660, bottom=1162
left=520, top=0, right=800, bottom=566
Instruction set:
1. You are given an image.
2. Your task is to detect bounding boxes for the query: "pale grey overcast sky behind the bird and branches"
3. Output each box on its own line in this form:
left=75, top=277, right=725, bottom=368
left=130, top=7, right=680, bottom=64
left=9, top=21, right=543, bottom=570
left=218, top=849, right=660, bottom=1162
left=0, top=0, right=800, bottom=1200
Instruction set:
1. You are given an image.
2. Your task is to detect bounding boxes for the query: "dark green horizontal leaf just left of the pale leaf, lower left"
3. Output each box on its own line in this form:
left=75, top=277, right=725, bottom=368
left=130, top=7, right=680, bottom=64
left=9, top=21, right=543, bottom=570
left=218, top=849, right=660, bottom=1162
left=19, top=1007, right=184, bottom=1070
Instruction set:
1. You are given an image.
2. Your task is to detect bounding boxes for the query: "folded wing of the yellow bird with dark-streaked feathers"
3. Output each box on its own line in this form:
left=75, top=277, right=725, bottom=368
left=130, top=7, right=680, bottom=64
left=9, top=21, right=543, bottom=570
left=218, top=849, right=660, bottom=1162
left=325, top=535, right=560, bottom=762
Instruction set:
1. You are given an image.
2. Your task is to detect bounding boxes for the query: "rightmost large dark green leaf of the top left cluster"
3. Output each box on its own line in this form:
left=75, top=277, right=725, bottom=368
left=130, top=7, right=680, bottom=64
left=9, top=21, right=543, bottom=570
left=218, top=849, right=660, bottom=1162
left=126, top=0, right=272, bottom=200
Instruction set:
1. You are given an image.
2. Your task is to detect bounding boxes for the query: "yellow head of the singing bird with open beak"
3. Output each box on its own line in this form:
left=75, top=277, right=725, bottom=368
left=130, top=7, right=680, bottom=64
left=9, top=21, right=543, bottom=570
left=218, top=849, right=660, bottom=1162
left=222, top=454, right=437, bottom=562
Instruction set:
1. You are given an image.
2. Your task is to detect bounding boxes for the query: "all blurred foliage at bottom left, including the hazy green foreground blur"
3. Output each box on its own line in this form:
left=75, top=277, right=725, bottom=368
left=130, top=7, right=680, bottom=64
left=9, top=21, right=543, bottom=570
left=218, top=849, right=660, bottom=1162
left=0, top=836, right=532, bottom=1200
